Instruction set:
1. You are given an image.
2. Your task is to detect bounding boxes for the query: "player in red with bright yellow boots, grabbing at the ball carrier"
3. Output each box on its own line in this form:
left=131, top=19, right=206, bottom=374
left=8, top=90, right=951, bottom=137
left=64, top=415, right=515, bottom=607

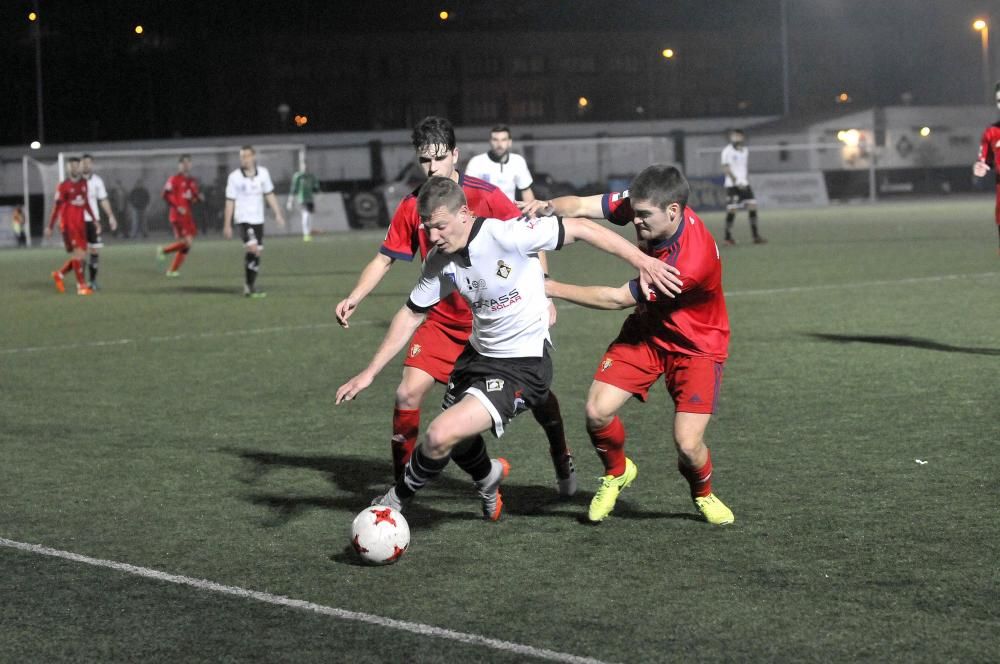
left=541, top=165, right=734, bottom=525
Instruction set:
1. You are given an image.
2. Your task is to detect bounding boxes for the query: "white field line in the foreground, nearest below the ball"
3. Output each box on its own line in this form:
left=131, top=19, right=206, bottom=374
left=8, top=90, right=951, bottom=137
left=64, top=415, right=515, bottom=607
left=0, top=537, right=605, bottom=664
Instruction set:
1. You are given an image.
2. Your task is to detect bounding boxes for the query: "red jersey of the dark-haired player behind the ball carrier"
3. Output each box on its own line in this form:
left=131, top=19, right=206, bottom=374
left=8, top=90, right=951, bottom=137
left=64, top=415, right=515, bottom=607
left=379, top=175, right=521, bottom=329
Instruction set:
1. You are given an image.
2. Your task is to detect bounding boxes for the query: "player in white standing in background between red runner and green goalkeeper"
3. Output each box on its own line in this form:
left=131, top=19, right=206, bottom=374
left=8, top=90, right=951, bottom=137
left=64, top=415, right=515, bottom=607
left=222, top=145, right=285, bottom=298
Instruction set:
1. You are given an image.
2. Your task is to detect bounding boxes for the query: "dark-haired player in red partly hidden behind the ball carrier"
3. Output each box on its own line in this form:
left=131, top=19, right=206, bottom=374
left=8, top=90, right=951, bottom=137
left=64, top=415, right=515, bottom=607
left=336, top=116, right=576, bottom=496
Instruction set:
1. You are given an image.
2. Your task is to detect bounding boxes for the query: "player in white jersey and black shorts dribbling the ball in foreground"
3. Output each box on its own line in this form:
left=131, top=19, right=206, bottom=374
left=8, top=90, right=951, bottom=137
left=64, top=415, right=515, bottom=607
left=336, top=177, right=680, bottom=521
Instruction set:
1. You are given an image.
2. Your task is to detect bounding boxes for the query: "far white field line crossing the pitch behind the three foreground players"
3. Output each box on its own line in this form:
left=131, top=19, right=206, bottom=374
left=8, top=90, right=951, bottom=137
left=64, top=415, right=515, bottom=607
left=0, top=272, right=1000, bottom=355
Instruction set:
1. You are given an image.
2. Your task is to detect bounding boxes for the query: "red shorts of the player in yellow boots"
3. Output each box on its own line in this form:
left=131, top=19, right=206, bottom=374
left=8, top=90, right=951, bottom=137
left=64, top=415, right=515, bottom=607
left=594, top=343, right=723, bottom=414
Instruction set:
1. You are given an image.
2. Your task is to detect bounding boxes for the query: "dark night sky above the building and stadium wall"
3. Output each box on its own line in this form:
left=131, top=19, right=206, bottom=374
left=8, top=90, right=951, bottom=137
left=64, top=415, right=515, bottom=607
left=0, top=0, right=1000, bottom=145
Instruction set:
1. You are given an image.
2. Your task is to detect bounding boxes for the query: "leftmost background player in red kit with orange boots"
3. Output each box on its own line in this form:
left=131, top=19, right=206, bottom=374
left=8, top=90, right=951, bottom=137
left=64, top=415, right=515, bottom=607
left=45, top=157, right=97, bottom=295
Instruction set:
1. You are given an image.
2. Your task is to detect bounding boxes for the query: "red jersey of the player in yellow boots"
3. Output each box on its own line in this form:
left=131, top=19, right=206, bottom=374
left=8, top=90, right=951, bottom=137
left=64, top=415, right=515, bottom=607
left=601, top=191, right=729, bottom=362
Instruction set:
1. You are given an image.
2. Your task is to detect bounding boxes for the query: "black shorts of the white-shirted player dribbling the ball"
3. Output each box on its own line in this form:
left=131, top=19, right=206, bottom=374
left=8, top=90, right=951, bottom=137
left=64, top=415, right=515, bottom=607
left=442, top=343, right=552, bottom=438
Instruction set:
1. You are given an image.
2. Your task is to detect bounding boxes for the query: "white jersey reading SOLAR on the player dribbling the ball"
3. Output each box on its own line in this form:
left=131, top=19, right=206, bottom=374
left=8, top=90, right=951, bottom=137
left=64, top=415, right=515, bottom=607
left=408, top=217, right=563, bottom=357
